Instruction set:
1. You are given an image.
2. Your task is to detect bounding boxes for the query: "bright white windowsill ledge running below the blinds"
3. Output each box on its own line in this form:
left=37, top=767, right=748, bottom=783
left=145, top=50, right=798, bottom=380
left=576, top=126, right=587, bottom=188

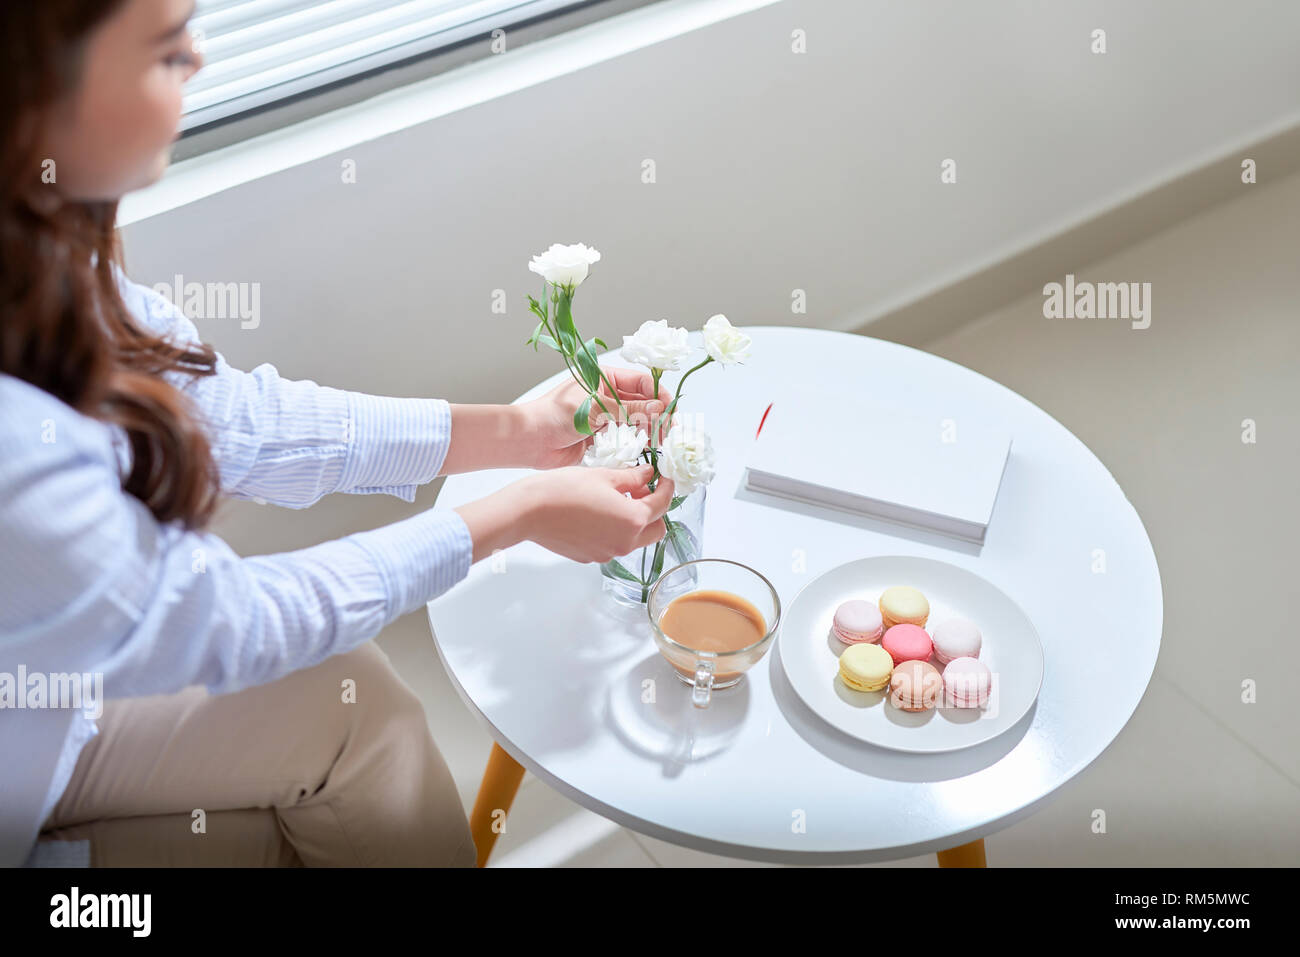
left=117, top=0, right=779, bottom=226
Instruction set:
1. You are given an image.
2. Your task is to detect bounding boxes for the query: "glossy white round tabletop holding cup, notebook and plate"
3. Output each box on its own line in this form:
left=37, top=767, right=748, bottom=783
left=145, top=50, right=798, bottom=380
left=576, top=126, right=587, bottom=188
left=429, top=326, right=1164, bottom=865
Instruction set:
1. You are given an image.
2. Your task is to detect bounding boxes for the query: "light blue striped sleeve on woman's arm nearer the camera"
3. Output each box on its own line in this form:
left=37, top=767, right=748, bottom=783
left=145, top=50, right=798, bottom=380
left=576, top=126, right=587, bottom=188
left=0, top=380, right=473, bottom=698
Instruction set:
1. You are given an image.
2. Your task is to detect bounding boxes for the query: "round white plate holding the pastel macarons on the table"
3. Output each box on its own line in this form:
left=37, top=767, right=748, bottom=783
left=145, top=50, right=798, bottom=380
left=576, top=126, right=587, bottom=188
left=777, top=555, right=1043, bottom=753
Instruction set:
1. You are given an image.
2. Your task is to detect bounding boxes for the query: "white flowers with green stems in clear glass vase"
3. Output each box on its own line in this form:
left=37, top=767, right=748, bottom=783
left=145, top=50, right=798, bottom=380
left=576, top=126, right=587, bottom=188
left=527, top=243, right=750, bottom=605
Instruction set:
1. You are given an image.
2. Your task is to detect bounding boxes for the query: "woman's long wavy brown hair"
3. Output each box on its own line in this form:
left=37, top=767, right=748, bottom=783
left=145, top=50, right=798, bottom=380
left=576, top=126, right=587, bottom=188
left=0, top=0, right=220, bottom=528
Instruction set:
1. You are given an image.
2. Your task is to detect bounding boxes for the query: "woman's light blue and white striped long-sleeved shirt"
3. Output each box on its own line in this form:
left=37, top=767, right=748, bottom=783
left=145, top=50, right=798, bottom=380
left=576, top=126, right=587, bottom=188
left=0, top=269, right=473, bottom=866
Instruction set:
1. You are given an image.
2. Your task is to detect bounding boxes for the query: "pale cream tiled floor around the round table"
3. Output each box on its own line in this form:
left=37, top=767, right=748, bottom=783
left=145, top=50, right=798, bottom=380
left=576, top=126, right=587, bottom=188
left=371, top=176, right=1300, bottom=867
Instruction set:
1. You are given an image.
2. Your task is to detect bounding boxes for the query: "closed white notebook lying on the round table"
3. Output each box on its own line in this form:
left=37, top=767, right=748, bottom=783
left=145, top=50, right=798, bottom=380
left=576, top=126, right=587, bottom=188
left=745, top=390, right=1011, bottom=544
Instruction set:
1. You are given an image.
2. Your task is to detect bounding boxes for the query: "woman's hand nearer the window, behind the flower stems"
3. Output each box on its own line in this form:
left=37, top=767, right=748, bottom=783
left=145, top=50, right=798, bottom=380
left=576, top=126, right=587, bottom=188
left=523, top=367, right=672, bottom=468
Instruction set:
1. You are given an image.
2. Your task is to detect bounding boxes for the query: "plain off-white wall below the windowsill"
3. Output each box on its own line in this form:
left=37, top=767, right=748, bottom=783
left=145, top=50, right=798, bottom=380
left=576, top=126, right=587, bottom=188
left=116, top=0, right=1300, bottom=546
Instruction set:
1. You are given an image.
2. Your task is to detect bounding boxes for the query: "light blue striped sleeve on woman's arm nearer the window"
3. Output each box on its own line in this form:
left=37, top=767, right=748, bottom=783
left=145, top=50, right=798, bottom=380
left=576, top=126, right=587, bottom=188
left=120, top=274, right=451, bottom=508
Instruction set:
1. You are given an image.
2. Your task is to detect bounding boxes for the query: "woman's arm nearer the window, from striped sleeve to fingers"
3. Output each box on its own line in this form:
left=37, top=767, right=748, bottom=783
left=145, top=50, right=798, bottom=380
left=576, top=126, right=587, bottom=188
left=120, top=274, right=672, bottom=488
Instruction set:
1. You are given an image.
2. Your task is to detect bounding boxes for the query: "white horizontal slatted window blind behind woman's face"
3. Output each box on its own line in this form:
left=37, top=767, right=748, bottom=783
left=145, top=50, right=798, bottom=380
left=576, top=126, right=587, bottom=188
left=181, top=0, right=590, bottom=130
